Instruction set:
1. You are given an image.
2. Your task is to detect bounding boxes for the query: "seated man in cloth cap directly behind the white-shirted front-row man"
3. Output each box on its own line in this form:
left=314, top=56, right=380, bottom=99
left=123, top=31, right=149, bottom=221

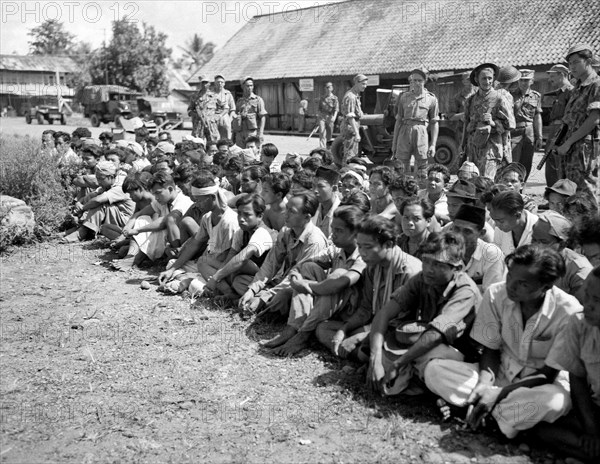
left=531, top=210, right=592, bottom=303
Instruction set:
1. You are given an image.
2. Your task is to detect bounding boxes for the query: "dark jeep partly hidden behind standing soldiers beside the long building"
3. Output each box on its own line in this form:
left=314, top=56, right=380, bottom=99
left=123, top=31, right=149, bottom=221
left=331, top=85, right=462, bottom=174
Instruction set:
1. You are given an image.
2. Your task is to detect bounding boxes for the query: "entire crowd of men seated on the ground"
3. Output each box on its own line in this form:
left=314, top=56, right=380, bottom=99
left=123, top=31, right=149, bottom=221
left=44, top=125, right=600, bottom=460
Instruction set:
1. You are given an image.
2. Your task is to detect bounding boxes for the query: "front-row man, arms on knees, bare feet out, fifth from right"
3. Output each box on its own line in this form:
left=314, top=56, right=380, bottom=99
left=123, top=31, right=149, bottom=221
left=265, top=206, right=367, bottom=356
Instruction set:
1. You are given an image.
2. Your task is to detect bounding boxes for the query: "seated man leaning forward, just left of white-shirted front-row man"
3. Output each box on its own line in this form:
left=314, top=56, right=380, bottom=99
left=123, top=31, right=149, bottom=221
left=367, top=232, right=481, bottom=395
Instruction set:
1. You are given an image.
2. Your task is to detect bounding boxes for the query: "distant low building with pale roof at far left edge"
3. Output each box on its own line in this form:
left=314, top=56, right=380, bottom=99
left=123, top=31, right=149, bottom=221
left=0, top=55, right=79, bottom=116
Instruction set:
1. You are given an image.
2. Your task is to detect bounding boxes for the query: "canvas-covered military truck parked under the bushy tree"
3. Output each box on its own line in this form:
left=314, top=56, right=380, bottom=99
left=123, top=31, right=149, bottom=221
left=81, top=85, right=141, bottom=128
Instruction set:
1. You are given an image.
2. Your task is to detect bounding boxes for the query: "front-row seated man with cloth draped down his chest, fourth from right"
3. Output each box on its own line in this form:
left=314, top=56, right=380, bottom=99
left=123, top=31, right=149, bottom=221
left=317, top=216, right=421, bottom=359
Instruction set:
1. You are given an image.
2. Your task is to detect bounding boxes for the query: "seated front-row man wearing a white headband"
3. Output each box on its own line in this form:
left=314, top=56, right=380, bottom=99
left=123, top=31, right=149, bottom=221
left=159, top=177, right=239, bottom=294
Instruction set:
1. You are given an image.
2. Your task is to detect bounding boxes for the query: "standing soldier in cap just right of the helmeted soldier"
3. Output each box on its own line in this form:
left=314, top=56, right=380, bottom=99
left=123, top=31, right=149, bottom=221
left=511, top=69, right=542, bottom=180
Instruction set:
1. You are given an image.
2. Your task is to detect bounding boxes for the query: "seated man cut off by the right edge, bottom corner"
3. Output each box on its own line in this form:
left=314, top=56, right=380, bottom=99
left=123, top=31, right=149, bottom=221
left=533, top=267, right=600, bottom=462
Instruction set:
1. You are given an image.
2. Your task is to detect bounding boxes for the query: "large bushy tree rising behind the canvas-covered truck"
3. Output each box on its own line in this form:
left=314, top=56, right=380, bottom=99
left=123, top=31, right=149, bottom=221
left=90, top=19, right=171, bottom=96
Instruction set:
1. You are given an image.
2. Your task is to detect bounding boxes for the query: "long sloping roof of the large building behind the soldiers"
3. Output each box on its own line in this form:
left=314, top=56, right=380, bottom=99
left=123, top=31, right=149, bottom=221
left=190, top=0, right=600, bottom=83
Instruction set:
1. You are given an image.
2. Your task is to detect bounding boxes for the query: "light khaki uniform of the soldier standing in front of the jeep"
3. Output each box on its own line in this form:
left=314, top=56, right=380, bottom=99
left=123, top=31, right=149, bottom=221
left=392, top=89, right=439, bottom=172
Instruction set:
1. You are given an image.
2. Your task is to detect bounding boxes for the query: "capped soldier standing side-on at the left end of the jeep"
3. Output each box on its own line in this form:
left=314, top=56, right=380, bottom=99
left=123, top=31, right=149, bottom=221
left=340, top=74, right=368, bottom=166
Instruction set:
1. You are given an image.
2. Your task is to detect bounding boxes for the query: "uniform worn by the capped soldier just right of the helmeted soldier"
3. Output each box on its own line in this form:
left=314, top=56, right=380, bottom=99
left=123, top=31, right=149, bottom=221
left=510, top=89, right=542, bottom=179
